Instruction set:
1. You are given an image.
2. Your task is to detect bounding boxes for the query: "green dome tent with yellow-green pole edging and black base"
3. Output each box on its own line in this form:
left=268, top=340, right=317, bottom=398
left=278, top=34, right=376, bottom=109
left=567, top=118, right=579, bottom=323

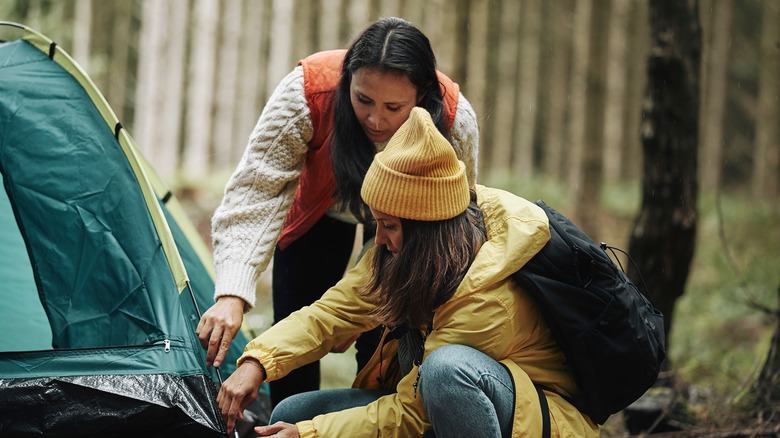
left=0, top=23, right=264, bottom=437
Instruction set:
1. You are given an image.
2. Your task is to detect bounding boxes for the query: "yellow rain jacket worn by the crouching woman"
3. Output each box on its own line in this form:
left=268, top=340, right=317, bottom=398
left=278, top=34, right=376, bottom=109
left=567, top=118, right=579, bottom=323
left=238, top=185, right=599, bottom=438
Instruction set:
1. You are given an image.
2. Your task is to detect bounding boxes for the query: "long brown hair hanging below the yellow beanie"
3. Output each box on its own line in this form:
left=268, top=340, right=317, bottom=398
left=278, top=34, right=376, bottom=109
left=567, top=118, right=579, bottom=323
left=363, top=191, right=487, bottom=328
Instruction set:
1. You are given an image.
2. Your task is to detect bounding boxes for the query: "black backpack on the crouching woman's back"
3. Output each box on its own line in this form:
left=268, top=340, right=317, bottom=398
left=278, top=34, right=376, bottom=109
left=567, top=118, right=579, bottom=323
left=512, top=201, right=666, bottom=424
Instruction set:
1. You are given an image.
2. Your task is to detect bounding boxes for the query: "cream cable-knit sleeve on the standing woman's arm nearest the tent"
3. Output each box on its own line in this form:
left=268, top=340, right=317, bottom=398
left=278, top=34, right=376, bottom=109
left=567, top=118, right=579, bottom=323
left=211, top=67, right=313, bottom=306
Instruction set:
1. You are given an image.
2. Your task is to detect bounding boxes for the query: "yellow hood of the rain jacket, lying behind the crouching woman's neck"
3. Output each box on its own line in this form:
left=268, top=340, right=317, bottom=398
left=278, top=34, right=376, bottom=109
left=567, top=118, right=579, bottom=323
left=455, top=184, right=550, bottom=296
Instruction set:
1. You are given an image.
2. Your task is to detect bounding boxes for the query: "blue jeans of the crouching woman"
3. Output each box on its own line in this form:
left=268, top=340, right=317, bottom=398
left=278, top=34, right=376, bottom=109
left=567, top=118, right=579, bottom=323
left=270, top=345, right=515, bottom=438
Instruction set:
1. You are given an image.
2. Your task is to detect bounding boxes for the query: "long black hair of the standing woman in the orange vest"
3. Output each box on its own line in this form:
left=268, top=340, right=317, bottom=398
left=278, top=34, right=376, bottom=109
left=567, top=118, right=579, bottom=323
left=328, top=18, right=450, bottom=223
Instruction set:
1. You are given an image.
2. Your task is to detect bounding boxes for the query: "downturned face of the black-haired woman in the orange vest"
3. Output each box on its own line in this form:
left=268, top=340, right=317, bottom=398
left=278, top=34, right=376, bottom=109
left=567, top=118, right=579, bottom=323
left=349, top=67, right=418, bottom=143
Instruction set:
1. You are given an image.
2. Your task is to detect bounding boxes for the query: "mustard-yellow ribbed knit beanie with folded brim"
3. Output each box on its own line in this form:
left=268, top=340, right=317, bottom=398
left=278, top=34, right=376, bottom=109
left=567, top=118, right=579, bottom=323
left=360, top=107, right=471, bottom=221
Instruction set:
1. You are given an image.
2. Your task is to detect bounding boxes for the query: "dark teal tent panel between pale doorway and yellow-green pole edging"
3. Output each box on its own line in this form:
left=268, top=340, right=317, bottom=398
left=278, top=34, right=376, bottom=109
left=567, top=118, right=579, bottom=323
left=0, top=36, right=185, bottom=348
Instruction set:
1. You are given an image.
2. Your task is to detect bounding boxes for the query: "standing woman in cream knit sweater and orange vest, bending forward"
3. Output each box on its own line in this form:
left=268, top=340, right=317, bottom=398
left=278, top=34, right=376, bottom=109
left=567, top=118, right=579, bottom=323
left=197, top=18, right=479, bottom=405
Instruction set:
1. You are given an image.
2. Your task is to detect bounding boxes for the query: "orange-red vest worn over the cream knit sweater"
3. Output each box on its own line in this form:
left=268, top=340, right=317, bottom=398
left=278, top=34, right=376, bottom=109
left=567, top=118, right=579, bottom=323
left=278, top=49, right=460, bottom=249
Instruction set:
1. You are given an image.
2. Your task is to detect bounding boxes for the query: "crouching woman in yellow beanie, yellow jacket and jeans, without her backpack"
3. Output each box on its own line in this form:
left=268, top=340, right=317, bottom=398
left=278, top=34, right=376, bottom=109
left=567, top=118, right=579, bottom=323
left=217, top=108, right=599, bottom=438
